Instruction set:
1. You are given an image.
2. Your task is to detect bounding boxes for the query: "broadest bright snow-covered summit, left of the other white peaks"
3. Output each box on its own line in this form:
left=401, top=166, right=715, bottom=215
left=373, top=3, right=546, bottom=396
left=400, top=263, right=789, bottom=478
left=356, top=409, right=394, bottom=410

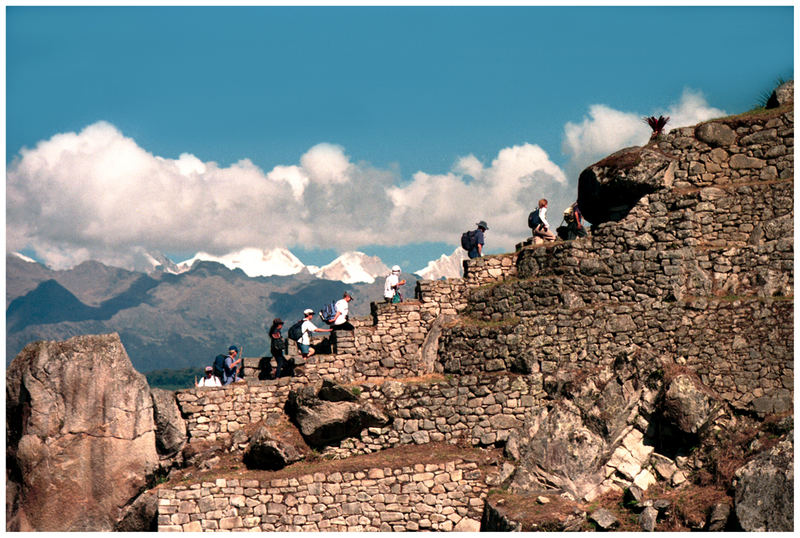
left=178, top=247, right=306, bottom=277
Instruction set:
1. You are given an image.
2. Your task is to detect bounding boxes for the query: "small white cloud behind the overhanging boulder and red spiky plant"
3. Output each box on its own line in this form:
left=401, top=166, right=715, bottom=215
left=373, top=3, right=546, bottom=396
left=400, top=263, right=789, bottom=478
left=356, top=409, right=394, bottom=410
left=562, top=89, right=726, bottom=178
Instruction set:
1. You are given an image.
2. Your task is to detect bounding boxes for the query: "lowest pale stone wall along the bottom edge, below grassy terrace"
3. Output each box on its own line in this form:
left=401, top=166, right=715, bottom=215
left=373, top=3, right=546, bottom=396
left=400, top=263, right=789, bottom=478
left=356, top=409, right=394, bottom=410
left=158, top=460, right=487, bottom=532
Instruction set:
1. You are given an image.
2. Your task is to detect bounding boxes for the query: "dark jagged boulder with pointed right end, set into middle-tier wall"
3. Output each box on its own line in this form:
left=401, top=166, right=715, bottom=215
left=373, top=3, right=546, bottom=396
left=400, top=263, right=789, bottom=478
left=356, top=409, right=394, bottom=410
left=286, top=381, right=390, bottom=447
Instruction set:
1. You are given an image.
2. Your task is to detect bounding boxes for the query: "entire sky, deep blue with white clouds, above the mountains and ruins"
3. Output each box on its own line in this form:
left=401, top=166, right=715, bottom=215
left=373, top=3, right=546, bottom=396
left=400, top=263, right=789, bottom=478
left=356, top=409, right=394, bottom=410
left=6, top=5, right=794, bottom=270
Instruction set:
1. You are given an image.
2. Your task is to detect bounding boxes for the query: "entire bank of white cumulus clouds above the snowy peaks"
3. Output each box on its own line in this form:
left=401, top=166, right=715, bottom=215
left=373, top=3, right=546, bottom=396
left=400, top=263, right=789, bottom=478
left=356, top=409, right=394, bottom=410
left=6, top=91, right=724, bottom=268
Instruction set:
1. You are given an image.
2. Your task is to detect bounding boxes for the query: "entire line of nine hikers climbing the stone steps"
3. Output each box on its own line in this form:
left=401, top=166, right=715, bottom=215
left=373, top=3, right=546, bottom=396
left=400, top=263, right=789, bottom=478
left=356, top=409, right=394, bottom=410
left=195, top=198, right=586, bottom=387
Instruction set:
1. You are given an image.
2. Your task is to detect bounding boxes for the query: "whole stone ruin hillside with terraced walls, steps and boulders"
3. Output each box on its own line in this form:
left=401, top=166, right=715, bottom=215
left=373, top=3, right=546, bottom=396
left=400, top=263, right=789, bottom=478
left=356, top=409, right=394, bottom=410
left=7, top=85, right=794, bottom=531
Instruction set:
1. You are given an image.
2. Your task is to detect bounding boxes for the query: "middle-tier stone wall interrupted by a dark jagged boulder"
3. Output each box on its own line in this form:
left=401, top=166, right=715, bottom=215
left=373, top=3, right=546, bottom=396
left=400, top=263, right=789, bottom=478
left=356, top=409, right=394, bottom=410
left=177, top=372, right=544, bottom=448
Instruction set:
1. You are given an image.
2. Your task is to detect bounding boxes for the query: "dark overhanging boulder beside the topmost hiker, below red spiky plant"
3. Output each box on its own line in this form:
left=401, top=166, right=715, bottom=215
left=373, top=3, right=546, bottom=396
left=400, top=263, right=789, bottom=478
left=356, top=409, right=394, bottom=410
left=578, top=146, right=676, bottom=225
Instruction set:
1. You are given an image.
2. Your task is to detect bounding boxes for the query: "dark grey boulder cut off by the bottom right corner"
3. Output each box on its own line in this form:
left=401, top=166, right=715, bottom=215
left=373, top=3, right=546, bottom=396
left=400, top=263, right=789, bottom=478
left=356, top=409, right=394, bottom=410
left=734, top=438, right=794, bottom=532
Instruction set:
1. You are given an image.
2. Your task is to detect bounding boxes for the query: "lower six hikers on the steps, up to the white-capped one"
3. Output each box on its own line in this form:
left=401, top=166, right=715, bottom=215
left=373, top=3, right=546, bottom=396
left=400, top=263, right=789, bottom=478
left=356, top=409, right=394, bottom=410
left=195, top=265, right=406, bottom=387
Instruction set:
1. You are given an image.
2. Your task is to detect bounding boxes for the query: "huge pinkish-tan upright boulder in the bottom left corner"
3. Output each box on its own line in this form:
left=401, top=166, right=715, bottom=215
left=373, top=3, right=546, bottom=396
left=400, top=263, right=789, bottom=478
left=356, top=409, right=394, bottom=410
left=6, top=334, right=159, bottom=531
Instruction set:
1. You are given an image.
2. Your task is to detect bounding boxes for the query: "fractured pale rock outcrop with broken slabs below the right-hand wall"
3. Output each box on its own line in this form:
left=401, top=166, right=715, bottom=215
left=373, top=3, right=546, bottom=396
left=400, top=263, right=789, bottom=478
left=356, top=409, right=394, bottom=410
left=506, top=348, right=660, bottom=500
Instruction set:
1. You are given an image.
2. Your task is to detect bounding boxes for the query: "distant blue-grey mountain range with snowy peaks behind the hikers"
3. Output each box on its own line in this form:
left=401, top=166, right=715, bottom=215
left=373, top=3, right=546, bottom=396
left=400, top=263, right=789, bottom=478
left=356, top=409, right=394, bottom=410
left=6, top=249, right=461, bottom=372
